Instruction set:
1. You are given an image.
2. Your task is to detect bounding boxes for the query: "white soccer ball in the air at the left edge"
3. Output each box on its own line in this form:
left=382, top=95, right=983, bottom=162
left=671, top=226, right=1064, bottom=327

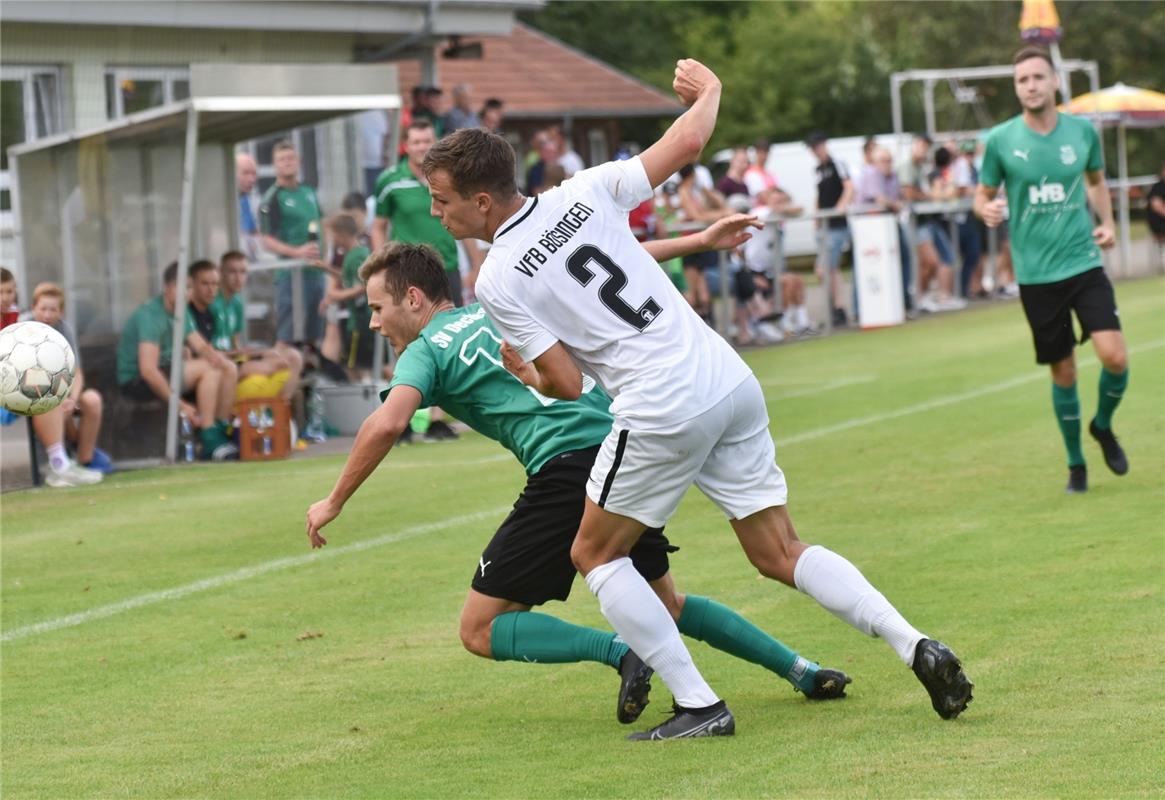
left=0, top=321, right=77, bottom=417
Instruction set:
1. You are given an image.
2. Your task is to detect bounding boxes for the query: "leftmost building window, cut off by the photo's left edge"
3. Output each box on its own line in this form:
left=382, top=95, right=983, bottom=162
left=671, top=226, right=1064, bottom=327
left=0, top=66, right=64, bottom=229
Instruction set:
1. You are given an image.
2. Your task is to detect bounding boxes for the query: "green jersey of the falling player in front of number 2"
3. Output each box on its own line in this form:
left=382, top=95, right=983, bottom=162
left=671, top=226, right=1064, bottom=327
left=382, top=303, right=612, bottom=475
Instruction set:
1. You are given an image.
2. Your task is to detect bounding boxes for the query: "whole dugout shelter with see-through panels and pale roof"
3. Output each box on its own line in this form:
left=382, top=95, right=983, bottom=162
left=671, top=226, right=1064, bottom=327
left=8, top=64, right=401, bottom=462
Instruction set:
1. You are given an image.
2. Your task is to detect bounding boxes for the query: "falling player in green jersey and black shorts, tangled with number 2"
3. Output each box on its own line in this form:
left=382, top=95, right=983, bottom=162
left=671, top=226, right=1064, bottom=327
left=306, top=220, right=849, bottom=723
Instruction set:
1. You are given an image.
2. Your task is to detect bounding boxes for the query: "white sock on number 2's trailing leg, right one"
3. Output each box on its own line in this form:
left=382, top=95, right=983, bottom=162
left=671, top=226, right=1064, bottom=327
left=796, top=545, right=926, bottom=666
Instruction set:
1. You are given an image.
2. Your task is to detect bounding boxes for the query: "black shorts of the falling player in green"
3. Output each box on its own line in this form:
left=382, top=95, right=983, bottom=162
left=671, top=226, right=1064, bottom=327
left=471, top=445, right=679, bottom=606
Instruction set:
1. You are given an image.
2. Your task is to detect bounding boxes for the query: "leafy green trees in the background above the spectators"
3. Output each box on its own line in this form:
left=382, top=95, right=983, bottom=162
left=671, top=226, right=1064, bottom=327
left=524, top=0, right=1165, bottom=174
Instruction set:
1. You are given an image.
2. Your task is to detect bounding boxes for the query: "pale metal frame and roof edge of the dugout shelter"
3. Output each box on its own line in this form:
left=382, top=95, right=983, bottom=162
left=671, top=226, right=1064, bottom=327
left=8, top=64, right=401, bottom=462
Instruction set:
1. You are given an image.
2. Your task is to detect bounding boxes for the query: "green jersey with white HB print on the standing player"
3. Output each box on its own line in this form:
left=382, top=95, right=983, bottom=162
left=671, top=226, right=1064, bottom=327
left=980, top=114, right=1104, bottom=284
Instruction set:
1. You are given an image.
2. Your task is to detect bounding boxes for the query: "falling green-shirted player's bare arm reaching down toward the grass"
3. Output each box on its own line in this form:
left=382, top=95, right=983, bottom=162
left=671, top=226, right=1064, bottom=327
left=306, top=385, right=421, bottom=548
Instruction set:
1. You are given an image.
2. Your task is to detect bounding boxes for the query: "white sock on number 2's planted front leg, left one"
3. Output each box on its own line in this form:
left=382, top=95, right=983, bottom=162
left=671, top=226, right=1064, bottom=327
left=586, top=558, right=720, bottom=708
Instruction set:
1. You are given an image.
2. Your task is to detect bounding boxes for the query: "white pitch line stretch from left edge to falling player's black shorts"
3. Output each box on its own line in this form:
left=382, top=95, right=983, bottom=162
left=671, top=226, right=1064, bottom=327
left=0, top=505, right=510, bottom=642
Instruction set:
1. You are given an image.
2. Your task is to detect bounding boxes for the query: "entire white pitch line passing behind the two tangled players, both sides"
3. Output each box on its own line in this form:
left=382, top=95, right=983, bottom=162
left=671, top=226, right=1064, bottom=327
left=0, top=339, right=1165, bottom=642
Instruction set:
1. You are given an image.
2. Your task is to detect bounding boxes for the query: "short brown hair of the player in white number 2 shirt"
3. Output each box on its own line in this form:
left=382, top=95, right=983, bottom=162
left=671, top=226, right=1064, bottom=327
left=422, top=128, right=517, bottom=200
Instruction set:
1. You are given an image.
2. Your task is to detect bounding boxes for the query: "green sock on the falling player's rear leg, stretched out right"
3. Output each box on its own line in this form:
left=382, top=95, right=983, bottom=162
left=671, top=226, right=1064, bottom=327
left=678, top=595, right=818, bottom=694
